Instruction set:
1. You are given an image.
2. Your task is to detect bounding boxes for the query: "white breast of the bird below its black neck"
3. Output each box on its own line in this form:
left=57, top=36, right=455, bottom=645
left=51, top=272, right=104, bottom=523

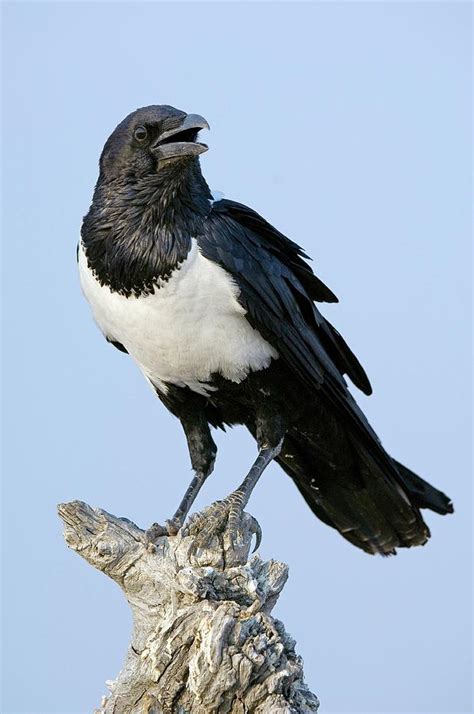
left=79, top=240, right=278, bottom=394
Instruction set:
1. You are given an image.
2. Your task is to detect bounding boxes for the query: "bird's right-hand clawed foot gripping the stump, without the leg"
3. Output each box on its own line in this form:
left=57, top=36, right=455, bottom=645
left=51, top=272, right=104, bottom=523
left=181, top=490, right=262, bottom=550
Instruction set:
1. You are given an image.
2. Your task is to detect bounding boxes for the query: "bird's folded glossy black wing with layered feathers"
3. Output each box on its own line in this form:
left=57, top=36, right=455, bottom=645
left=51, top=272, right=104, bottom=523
left=197, top=199, right=410, bottom=481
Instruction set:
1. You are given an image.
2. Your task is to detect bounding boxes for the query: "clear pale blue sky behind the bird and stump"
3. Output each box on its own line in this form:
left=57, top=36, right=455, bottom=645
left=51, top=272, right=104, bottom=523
left=2, top=2, right=471, bottom=714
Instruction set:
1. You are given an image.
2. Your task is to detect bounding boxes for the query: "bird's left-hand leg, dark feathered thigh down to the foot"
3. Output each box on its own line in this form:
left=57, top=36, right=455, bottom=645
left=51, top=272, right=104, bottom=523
left=147, top=413, right=217, bottom=541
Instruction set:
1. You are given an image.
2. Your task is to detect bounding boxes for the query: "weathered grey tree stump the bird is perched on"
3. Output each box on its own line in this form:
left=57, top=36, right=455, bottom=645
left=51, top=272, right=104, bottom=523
left=58, top=501, right=318, bottom=714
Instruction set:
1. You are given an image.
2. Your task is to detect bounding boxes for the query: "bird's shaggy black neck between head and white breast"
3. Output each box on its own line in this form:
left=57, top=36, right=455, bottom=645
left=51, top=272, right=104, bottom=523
left=81, top=161, right=211, bottom=296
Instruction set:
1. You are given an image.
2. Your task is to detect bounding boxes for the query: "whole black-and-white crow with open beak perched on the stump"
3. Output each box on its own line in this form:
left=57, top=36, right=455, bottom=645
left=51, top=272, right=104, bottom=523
left=77, top=105, right=453, bottom=555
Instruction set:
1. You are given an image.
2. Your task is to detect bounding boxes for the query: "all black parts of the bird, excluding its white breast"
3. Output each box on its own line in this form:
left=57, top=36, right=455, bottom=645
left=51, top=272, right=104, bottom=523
left=82, top=107, right=452, bottom=554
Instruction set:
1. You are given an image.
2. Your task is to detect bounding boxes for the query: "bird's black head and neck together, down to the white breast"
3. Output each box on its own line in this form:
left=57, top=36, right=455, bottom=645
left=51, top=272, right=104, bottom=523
left=81, top=105, right=212, bottom=297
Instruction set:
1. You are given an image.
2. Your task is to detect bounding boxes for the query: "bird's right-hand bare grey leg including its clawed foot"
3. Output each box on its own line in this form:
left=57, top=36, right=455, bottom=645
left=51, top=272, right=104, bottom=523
left=184, top=438, right=283, bottom=548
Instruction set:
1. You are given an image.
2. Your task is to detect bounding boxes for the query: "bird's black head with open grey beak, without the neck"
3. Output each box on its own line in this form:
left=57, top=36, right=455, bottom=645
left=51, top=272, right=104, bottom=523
left=100, top=104, right=209, bottom=181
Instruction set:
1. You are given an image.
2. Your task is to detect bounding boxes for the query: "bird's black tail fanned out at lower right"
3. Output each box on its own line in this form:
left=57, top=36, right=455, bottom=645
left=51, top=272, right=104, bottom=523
left=278, top=425, right=453, bottom=555
